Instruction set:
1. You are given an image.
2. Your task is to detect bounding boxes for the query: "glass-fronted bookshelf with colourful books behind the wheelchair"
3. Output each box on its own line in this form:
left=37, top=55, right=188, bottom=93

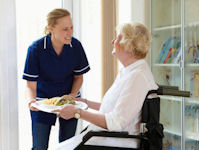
left=150, top=0, right=199, bottom=150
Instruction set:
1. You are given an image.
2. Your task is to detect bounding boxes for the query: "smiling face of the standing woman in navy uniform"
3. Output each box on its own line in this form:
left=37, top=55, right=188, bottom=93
left=50, top=16, right=73, bottom=44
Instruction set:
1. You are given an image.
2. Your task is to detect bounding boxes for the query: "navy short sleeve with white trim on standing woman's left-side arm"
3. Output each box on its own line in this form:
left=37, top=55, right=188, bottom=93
left=23, top=45, right=39, bottom=81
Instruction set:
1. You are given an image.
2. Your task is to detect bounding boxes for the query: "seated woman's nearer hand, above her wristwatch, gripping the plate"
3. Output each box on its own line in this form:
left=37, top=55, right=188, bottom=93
left=52, top=104, right=78, bottom=119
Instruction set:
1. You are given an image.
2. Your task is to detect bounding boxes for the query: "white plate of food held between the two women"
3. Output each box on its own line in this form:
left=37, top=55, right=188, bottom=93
left=31, top=95, right=88, bottom=113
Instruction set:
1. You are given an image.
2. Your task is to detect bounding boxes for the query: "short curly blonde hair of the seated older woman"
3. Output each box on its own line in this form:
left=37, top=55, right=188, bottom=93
left=117, top=23, right=151, bottom=59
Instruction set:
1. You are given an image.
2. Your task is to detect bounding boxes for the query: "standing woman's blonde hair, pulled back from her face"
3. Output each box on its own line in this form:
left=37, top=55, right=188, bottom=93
left=44, top=8, right=70, bottom=35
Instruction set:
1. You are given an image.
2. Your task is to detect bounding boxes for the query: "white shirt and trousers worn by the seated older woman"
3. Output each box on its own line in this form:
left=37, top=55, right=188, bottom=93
left=54, top=59, right=158, bottom=150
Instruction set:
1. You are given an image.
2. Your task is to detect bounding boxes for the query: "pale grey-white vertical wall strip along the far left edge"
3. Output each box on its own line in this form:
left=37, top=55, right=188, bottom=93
left=0, top=0, right=18, bottom=150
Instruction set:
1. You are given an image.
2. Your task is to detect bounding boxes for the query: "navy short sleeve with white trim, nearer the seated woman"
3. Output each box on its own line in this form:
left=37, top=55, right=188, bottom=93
left=73, top=42, right=90, bottom=75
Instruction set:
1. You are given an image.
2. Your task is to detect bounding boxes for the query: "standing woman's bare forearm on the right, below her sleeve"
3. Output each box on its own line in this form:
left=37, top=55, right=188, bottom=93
left=70, top=75, right=83, bottom=97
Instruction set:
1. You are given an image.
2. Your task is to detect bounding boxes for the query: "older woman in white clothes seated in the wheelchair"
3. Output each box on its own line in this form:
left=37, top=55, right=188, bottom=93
left=53, top=23, right=158, bottom=150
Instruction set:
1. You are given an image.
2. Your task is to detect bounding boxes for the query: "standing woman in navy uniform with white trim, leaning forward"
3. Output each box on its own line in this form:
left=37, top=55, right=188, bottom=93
left=23, top=9, right=90, bottom=150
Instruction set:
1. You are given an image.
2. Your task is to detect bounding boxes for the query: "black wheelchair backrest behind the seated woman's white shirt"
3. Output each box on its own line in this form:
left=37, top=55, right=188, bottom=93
left=140, top=91, right=164, bottom=150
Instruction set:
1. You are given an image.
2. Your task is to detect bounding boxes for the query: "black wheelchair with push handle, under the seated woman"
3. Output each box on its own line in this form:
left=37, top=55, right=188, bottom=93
left=75, top=85, right=190, bottom=150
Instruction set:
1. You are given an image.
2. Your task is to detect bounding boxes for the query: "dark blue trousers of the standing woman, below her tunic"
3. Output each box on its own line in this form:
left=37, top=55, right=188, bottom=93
left=32, top=118, right=77, bottom=150
